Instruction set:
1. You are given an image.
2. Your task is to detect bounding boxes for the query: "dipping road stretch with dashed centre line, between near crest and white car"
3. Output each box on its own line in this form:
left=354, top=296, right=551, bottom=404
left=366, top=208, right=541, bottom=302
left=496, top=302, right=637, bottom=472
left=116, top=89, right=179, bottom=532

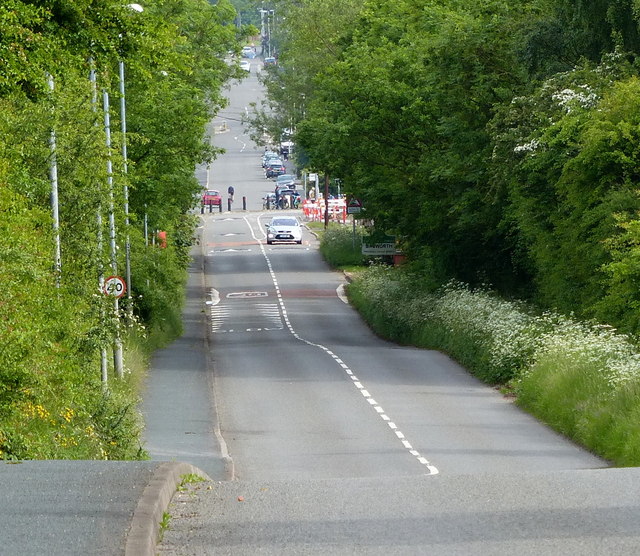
left=203, top=213, right=605, bottom=480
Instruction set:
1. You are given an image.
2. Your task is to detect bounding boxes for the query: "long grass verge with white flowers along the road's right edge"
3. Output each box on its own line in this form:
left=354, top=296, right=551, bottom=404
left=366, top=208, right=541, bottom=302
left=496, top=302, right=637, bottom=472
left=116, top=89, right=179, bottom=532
left=348, top=267, right=640, bottom=466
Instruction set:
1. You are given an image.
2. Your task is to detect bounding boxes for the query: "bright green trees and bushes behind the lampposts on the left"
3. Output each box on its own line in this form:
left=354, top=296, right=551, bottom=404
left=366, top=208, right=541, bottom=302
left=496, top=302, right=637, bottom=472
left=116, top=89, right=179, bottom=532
left=0, top=0, right=243, bottom=458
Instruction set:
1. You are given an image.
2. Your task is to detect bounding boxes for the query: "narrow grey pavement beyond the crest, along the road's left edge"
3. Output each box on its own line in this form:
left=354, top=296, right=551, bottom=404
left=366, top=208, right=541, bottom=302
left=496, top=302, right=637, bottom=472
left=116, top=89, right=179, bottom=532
left=141, top=234, right=233, bottom=480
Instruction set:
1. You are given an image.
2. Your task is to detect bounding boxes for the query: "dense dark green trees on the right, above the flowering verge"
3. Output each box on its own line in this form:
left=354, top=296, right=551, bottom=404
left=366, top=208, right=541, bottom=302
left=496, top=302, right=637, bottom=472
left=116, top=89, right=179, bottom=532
left=255, top=0, right=640, bottom=332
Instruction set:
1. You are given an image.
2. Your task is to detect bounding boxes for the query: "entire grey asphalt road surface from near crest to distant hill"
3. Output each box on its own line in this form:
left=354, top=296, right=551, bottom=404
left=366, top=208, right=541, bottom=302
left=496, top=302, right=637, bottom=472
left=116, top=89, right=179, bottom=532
left=145, top=60, right=640, bottom=555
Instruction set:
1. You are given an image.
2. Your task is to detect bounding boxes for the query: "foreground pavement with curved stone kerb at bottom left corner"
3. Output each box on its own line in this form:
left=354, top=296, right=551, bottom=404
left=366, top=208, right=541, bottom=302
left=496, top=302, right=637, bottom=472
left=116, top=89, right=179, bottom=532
left=0, top=460, right=208, bottom=556
